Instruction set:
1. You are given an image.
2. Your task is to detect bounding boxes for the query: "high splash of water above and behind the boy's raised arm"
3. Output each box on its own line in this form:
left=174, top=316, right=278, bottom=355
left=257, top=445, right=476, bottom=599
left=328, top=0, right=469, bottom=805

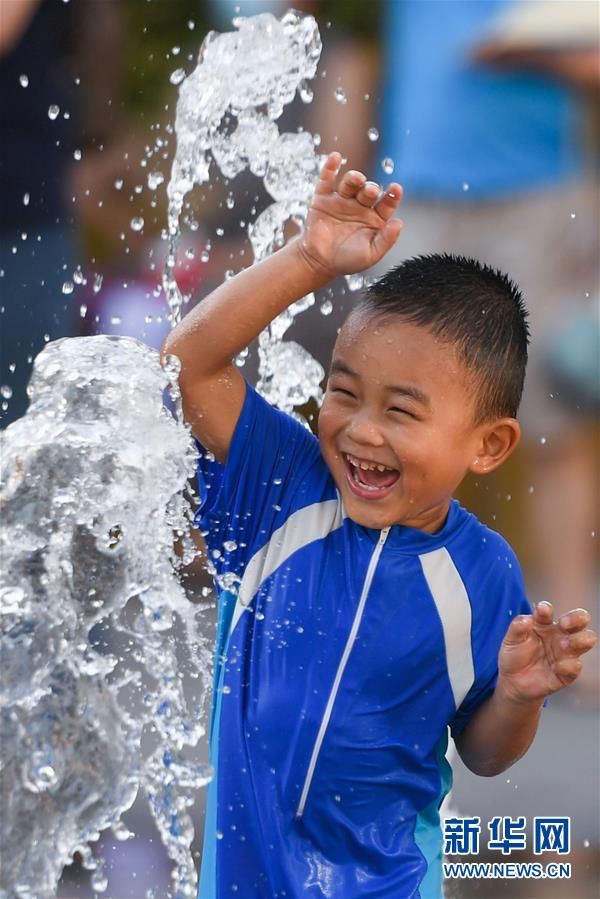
left=163, top=11, right=325, bottom=411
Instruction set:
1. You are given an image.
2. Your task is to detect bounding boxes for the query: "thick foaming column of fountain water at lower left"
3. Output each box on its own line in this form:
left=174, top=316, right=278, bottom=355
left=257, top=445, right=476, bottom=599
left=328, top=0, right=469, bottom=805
left=0, top=336, right=210, bottom=899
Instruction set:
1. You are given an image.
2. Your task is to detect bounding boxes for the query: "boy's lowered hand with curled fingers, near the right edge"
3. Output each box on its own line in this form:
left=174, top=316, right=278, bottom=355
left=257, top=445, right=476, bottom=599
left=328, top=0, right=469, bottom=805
left=498, top=602, right=596, bottom=702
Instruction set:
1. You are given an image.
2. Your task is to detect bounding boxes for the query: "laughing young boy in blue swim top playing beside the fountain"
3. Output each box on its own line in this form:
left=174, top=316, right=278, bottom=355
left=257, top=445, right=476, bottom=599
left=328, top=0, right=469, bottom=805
left=164, top=153, right=595, bottom=899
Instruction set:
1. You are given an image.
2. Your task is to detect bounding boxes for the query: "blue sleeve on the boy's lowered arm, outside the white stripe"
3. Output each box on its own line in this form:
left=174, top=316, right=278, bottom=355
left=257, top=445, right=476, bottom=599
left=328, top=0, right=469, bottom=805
left=450, top=556, right=531, bottom=738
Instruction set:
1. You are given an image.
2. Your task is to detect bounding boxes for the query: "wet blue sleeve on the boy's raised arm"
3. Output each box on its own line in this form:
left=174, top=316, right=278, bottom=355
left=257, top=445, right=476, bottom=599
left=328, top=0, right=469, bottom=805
left=195, top=384, right=324, bottom=572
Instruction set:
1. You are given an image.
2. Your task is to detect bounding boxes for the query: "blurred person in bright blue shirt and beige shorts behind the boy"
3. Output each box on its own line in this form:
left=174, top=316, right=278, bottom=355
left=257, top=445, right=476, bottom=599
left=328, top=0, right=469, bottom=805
left=382, top=0, right=600, bottom=667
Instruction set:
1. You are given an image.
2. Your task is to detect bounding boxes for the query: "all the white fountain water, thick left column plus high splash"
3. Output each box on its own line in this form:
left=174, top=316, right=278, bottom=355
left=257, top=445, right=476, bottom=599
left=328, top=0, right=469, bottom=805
left=0, top=12, right=324, bottom=899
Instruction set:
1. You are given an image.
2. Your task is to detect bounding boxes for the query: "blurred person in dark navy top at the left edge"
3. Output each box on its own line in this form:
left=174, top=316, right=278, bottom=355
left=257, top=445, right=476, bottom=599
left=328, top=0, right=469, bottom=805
left=0, top=0, right=77, bottom=426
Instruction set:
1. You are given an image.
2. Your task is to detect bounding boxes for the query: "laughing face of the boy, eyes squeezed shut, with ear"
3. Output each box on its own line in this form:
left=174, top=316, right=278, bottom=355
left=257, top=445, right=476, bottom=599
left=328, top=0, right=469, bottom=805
left=319, top=310, right=496, bottom=533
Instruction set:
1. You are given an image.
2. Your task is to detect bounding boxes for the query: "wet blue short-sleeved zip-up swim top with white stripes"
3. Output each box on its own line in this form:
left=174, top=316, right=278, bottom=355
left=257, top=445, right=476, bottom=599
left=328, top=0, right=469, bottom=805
left=198, top=386, right=529, bottom=899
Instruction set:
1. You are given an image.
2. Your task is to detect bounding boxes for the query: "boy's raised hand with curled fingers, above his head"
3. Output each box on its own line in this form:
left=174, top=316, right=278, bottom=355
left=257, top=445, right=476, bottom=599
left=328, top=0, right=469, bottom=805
left=298, top=153, right=402, bottom=280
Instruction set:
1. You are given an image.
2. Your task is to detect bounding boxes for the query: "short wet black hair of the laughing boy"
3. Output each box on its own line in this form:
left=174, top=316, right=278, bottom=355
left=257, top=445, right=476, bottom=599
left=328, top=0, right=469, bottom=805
left=355, top=253, right=529, bottom=424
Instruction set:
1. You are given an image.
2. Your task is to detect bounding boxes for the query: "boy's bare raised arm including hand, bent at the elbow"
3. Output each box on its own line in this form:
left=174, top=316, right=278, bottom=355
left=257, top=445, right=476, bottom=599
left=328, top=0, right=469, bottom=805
left=161, top=153, right=402, bottom=462
